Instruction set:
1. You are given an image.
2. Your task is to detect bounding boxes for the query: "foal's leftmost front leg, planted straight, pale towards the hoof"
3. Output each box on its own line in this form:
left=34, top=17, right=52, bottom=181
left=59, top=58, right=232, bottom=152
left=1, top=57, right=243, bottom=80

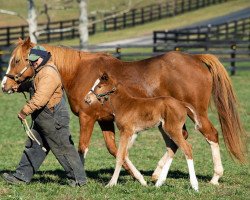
left=107, top=132, right=130, bottom=187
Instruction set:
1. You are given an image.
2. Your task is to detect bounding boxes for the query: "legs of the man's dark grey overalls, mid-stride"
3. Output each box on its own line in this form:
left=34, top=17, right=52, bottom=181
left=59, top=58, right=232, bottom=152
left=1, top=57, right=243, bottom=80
left=13, top=97, right=86, bottom=185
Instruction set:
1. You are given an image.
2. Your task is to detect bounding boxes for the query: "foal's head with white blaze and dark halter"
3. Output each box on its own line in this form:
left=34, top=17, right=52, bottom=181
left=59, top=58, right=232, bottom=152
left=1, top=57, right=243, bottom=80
left=85, top=72, right=117, bottom=105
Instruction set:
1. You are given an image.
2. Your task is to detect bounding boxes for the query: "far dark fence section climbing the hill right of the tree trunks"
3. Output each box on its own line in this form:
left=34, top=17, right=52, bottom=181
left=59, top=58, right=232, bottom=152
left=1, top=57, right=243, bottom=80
left=104, top=0, right=227, bottom=31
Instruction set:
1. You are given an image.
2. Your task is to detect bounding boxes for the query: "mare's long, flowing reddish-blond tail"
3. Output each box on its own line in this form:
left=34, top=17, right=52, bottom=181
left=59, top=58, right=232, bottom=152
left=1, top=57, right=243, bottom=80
left=195, top=54, right=246, bottom=163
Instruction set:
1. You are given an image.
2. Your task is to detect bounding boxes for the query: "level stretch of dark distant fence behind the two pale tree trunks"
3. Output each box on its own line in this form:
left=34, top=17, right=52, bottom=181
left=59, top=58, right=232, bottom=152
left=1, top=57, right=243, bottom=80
left=0, top=17, right=96, bottom=46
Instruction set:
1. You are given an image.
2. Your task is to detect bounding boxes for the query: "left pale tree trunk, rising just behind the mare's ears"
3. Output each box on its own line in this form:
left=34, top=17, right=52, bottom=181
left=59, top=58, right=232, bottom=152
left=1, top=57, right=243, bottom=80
left=28, top=0, right=37, bottom=43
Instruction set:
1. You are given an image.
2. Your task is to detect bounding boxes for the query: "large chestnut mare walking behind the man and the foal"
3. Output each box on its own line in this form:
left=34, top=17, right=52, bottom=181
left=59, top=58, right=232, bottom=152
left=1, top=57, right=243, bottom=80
left=2, top=38, right=245, bottom=184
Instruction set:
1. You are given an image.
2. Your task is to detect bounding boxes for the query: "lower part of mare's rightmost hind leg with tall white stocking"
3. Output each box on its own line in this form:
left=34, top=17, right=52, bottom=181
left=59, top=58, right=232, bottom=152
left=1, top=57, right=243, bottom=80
left=196, top=115, right=223, bottom=185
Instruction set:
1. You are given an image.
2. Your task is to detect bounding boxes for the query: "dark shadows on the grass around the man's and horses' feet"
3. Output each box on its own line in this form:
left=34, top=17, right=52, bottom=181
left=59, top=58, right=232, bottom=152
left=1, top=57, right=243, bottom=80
left=0, top=168, right=212, bottom=185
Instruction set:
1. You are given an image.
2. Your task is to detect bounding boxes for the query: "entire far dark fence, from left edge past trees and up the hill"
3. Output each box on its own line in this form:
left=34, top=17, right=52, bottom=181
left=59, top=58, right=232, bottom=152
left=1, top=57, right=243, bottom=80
left=0, top=0, right=228, bottom=47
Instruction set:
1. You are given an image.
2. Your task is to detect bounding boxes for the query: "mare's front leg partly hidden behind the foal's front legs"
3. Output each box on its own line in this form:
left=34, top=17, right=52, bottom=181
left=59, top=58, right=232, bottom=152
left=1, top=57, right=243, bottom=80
left=98, top=121, right=135, bottom=177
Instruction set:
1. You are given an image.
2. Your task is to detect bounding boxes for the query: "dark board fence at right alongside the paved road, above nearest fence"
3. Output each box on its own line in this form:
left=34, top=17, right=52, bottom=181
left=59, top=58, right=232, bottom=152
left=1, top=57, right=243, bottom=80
left=153, top=17, right=250, bottom=48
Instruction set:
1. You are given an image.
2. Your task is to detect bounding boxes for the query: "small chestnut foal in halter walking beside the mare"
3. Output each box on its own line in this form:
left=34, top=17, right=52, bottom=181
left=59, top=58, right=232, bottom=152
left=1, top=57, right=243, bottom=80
left=85, top=73, right=201, bottom=191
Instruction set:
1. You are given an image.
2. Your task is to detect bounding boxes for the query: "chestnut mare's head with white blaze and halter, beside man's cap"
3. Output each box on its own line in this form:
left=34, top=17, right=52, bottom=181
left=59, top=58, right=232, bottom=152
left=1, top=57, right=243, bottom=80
left=2, top=38, right=35, bottom=94
